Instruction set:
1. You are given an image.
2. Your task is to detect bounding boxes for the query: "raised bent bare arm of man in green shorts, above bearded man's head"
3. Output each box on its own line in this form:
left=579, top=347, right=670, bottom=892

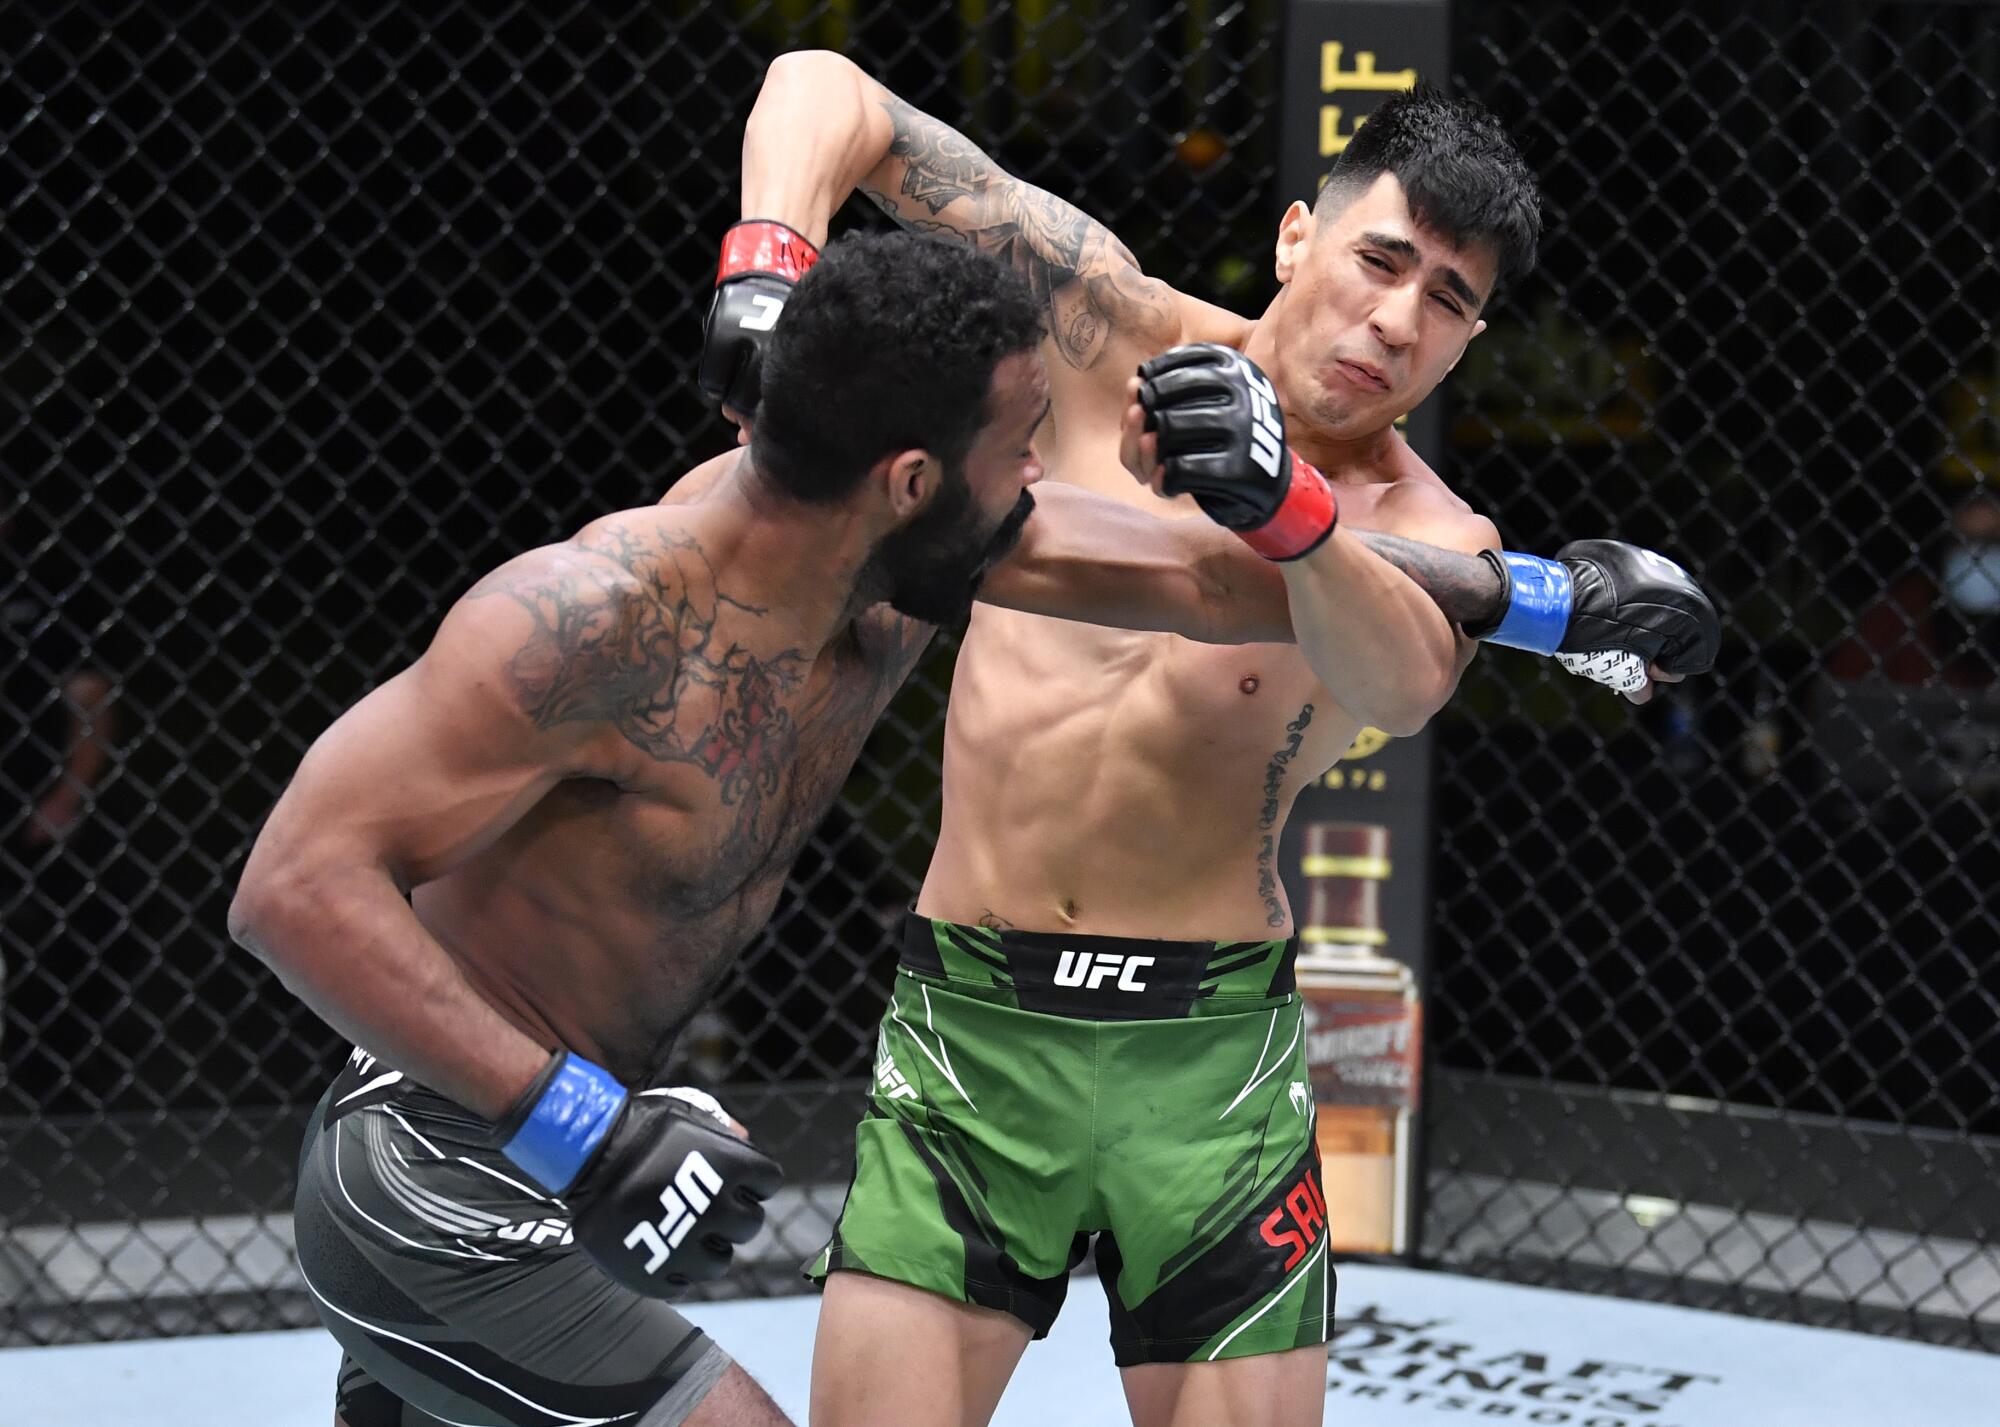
left=742, top=50, right=1186, bottom=371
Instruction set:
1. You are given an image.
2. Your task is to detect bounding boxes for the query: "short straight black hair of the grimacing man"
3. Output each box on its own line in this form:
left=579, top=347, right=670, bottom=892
left=1312, top=84, right=1542, bottom=288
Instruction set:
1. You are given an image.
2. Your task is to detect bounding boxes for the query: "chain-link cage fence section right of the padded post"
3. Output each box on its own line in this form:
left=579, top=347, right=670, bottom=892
left=1422, top=0, right=2000, bottom=1347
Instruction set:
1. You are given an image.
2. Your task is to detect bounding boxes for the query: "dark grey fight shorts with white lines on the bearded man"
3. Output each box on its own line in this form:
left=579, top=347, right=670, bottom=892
left=294, top=1051, right=730, bottom=1427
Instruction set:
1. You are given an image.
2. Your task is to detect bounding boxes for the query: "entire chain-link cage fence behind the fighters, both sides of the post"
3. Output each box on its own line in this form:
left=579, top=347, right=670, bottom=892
left=0, top=0, right=2000, bottom=1345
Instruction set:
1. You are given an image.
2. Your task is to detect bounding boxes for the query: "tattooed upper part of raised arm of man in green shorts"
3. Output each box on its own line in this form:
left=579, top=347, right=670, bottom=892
left=862, top=100, right=1174, bottom=370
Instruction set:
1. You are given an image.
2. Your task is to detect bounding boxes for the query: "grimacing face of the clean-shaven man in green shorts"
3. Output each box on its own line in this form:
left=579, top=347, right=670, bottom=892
left=1274, top=174, right=1498, bottom=438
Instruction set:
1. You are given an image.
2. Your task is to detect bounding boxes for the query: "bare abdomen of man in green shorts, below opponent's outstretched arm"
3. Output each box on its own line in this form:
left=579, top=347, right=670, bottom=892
left=918, top=606, right=1360, bottom=941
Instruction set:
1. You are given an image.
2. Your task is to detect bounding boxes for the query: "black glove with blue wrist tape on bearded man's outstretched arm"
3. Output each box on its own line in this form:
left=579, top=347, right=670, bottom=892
left=1466, top=540, right=1722, bottom=676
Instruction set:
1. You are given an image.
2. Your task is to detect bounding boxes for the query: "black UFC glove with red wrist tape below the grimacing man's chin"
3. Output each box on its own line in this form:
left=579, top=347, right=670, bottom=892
left=1138, top=342, right=1340, bottom=560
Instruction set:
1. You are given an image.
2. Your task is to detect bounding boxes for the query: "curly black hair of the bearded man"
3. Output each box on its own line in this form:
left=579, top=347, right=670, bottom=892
left=750, top=232, right=1042, bottom=502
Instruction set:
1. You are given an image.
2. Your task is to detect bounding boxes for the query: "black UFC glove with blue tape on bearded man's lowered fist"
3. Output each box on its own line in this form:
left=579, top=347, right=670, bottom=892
left=494, top=1051, right=784, bottom=1299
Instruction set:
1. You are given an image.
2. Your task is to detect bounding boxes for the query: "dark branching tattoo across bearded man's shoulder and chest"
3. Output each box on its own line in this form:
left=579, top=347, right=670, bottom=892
left=472, top=528, right=810, bottom=835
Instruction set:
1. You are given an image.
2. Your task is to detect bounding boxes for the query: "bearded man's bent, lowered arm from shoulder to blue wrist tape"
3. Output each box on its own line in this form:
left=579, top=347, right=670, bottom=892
left=230, top=548, right=606, bottom=1117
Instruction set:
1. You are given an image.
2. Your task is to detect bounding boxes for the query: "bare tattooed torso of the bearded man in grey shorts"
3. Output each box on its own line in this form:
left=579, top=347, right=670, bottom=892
left=412, top=458, right=930, bottom=1083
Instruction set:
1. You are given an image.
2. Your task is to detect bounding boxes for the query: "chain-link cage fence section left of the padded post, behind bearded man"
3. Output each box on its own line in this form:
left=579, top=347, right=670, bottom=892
left=0, top=0, right=1276, bottom=1341
